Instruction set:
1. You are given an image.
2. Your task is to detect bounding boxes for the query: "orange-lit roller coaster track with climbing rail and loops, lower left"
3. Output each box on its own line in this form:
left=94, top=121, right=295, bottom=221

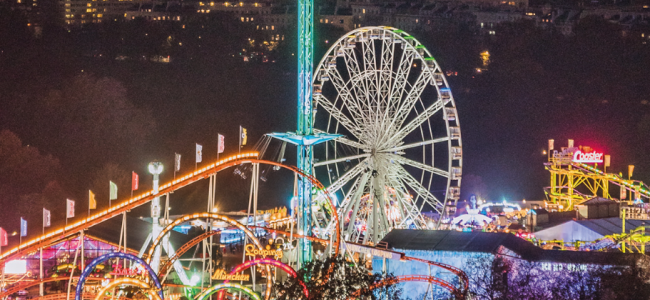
left=0, top=152, right=469, bottom=300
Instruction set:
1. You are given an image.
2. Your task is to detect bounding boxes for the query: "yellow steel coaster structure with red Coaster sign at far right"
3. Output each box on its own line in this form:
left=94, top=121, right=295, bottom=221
left=544, top=140, right=650, bottom=211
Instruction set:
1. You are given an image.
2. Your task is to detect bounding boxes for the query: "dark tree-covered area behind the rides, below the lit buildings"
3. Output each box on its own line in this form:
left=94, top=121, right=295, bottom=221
left=0, top=9, right=650, bottom=237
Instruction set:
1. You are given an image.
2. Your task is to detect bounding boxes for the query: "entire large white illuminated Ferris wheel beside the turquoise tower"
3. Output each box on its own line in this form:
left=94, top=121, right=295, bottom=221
left=312, top=27, right=462, bottom=244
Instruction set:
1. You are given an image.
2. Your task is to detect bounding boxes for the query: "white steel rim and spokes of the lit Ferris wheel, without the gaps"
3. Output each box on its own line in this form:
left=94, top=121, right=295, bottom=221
left=312, top=27, right=462, bottom=243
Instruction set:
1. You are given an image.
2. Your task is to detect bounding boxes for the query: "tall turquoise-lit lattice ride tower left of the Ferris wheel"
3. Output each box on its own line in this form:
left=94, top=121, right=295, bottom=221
left=270, top=0, right=340, bottom=266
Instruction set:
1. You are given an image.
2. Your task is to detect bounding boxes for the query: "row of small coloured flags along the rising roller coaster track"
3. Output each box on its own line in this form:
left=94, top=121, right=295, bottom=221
left=0, top=126, right=248, bottom=247
